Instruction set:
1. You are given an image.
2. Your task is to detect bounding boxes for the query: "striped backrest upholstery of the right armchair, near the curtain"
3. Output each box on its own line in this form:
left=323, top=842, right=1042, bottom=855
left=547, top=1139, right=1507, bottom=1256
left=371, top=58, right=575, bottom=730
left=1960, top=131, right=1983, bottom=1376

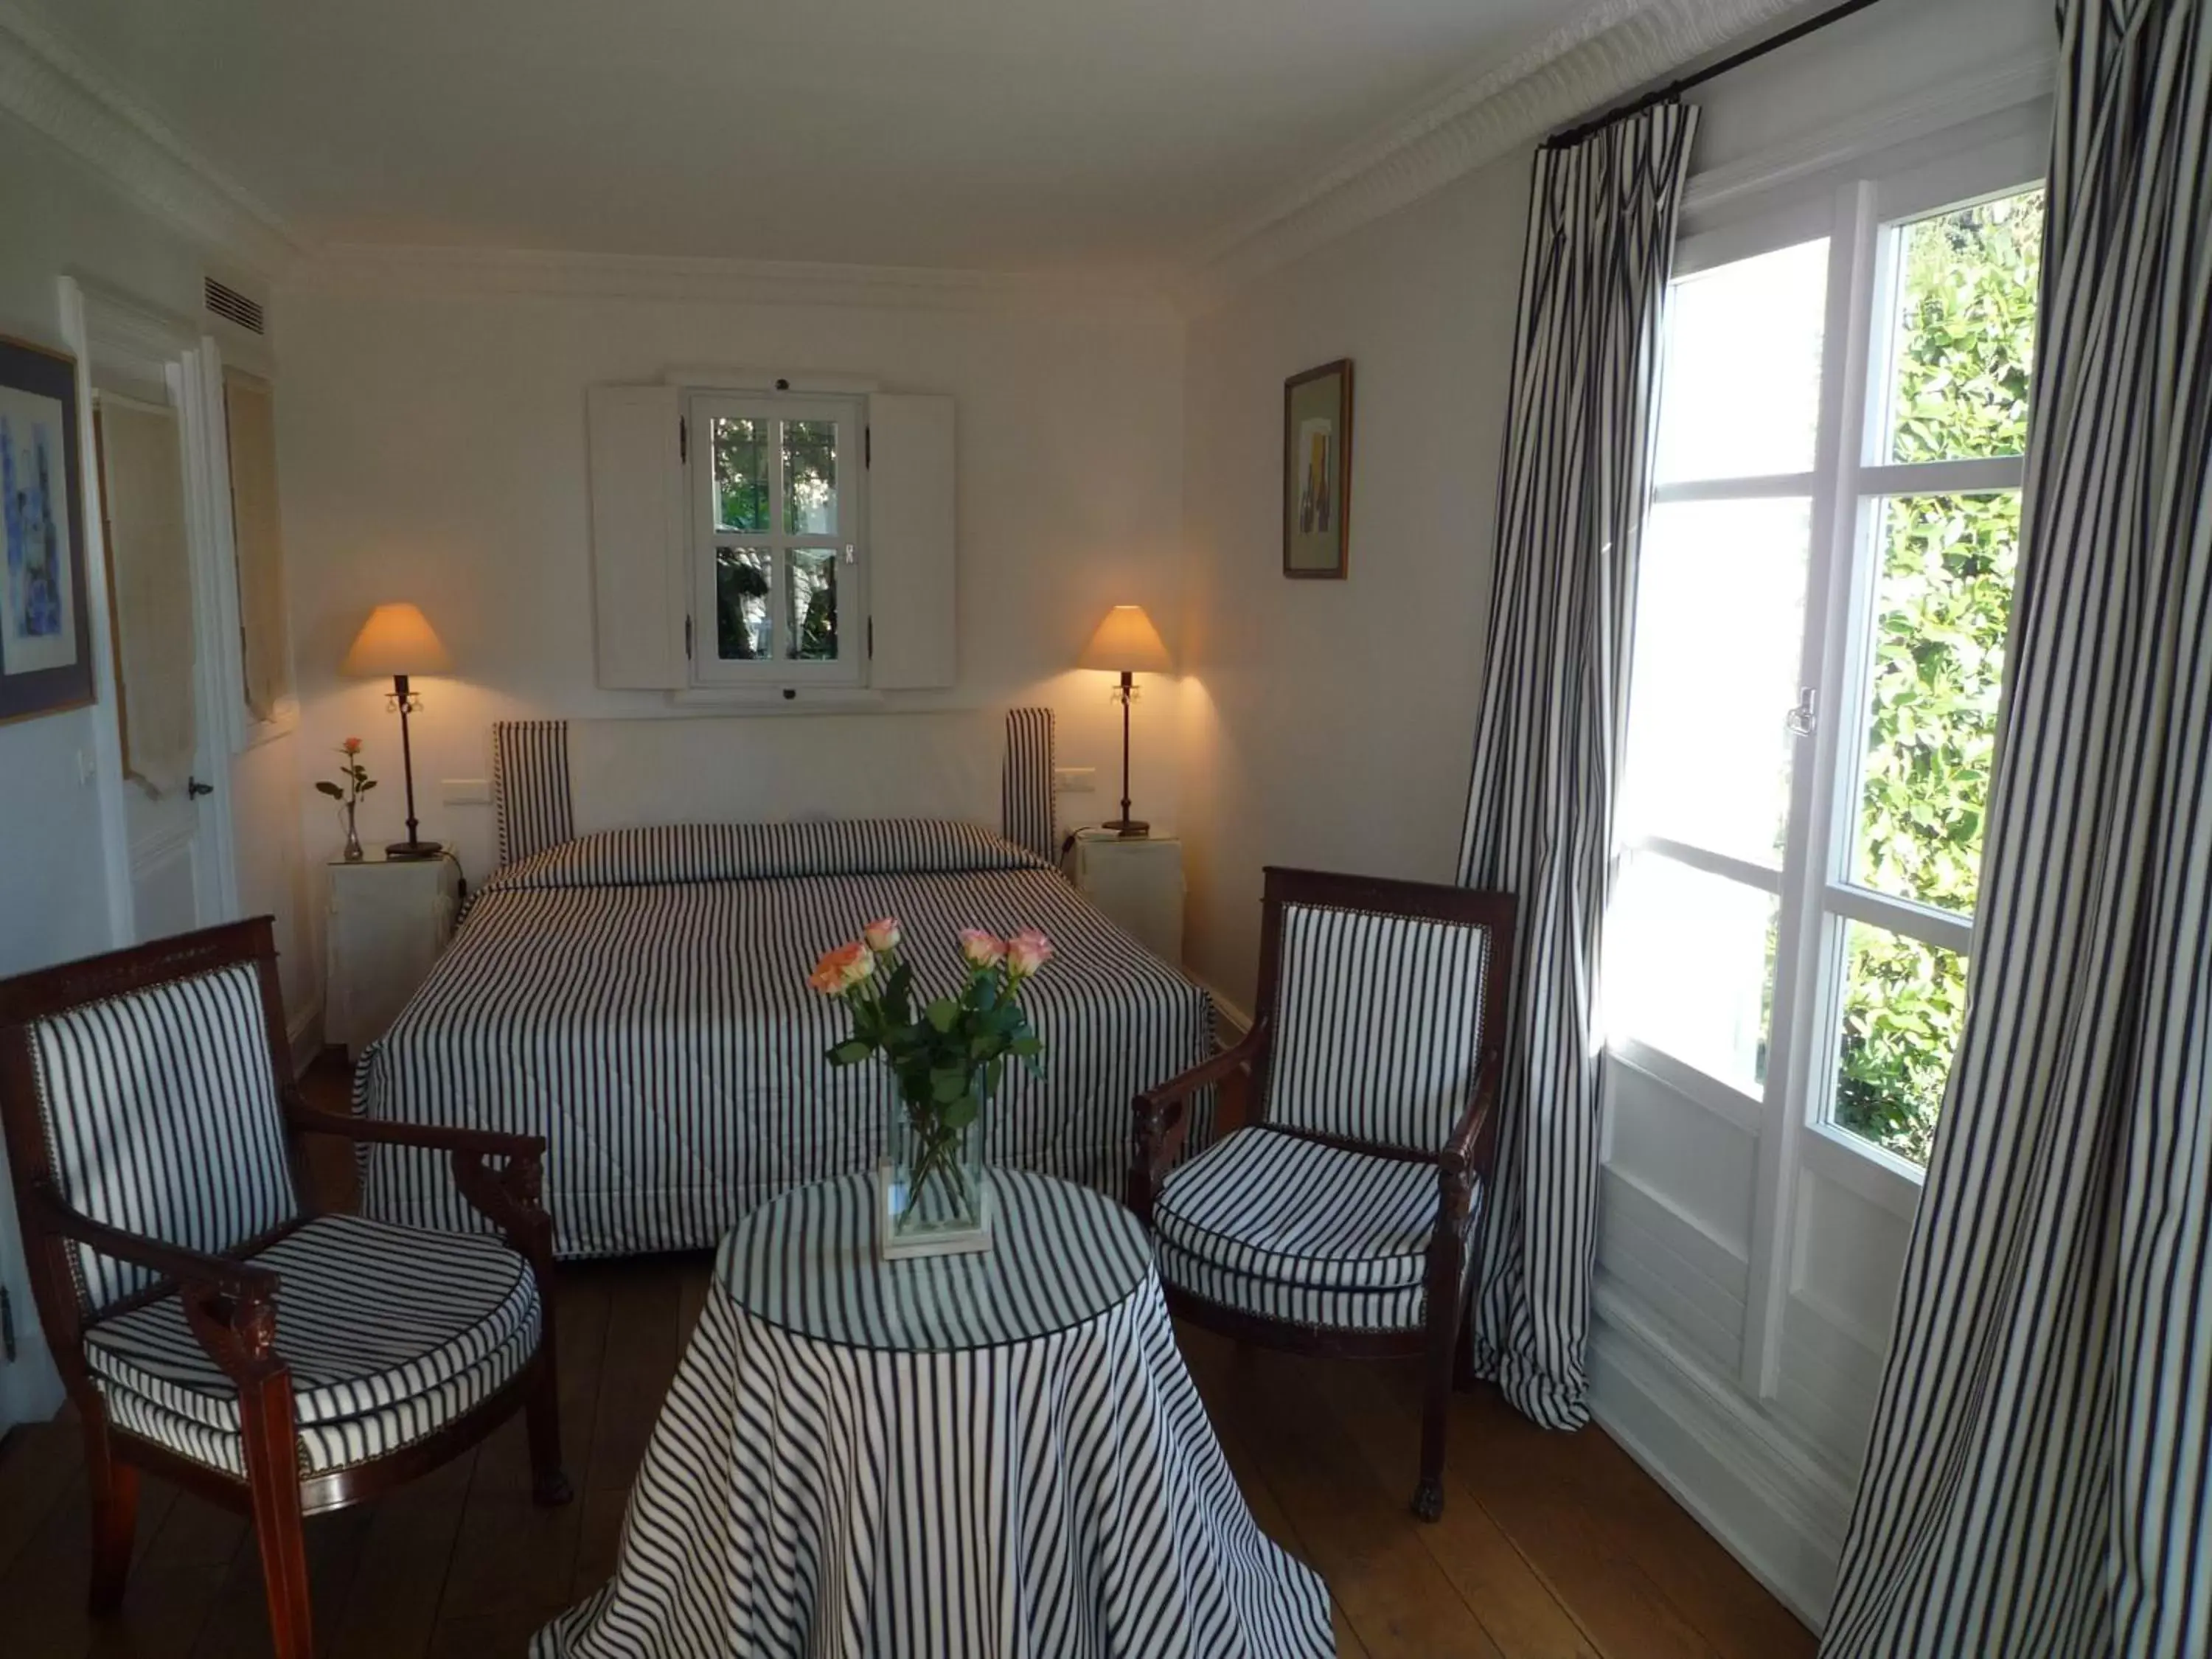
left=1267, top=905, right=1489, bottom=1152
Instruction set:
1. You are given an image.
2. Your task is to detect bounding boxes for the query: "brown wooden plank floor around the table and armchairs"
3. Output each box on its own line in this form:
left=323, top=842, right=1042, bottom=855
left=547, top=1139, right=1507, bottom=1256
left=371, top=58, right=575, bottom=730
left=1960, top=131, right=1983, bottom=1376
left=0, top=1071, right=1814, bottom=1659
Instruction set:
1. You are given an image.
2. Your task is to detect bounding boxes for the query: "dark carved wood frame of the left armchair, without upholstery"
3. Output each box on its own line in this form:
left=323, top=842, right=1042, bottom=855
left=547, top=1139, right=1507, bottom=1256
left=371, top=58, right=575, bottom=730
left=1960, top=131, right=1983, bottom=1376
left=0, top=916, right=571, bottom=1659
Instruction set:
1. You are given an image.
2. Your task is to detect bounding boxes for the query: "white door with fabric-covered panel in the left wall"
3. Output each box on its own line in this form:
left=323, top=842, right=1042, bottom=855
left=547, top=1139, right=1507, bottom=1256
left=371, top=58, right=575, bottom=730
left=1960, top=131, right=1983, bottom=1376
left=95, top=389, right=228, bottom=940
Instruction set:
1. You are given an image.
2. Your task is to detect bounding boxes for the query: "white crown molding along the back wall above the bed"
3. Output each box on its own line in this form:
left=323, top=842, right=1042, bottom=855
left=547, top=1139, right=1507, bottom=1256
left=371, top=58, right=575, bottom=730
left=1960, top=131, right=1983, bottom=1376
left=285, top=243, right=1177, bottom=323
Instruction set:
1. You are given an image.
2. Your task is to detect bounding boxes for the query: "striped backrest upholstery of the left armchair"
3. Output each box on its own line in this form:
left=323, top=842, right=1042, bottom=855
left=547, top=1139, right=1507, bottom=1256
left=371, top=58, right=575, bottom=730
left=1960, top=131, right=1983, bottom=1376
left=29, top=962, right=301, bottom=1312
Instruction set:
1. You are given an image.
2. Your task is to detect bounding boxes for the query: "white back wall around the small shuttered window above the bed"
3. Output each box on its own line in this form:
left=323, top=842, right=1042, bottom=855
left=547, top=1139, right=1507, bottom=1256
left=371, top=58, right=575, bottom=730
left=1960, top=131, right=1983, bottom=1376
left=276, top=283, right=1183, bottom=880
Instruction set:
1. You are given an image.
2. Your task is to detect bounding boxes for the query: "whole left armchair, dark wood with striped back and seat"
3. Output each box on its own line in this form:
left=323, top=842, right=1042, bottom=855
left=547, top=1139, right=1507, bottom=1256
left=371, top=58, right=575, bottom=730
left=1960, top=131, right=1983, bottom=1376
left=0, top=918, right=568, bottom=1659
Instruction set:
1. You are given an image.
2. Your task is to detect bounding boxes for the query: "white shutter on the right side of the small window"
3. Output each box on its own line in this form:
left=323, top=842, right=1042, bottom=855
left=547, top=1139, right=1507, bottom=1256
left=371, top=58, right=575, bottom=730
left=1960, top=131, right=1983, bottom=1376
left=867, top=392, right=960, bottom=690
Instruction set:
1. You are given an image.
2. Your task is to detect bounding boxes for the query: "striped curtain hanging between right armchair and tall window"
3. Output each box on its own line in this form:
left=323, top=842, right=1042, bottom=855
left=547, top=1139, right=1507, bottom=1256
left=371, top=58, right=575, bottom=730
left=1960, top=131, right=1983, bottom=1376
left=1460, top=104, right=1697, bottom=1429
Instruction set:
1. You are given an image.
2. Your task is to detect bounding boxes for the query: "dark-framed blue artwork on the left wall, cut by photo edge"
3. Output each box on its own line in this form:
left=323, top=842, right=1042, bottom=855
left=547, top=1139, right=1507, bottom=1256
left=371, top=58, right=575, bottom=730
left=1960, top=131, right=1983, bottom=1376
left=0, top=336, right=93, bottom=721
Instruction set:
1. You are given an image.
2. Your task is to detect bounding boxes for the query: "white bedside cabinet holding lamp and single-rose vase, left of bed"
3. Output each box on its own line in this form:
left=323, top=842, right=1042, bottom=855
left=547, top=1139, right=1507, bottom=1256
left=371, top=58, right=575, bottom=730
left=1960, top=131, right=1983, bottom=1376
left=323, top=852, right=460, bottom=1057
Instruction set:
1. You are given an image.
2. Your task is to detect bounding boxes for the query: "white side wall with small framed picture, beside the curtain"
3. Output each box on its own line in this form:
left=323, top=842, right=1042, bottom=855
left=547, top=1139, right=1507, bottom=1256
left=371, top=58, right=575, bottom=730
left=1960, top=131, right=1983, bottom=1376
left=1183, top=157, right=1528, bottom=1006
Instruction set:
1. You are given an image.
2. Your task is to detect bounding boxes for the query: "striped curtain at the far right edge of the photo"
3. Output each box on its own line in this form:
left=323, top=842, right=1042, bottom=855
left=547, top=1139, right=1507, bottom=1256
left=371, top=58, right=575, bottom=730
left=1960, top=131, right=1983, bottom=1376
left=1820, top=0, right=2212, bottom=1659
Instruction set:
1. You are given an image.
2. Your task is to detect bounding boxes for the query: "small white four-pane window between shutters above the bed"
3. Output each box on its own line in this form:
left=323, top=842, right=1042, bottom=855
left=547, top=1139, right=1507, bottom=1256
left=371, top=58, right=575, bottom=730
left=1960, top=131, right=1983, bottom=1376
left=686, top=396, right=867, bottom=684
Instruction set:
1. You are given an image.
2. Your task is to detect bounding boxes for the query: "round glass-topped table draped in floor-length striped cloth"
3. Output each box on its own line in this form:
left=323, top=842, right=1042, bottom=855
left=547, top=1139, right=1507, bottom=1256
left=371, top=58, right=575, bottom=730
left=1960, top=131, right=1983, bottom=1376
left=531, top=1170, right=1336, bottom=1659
